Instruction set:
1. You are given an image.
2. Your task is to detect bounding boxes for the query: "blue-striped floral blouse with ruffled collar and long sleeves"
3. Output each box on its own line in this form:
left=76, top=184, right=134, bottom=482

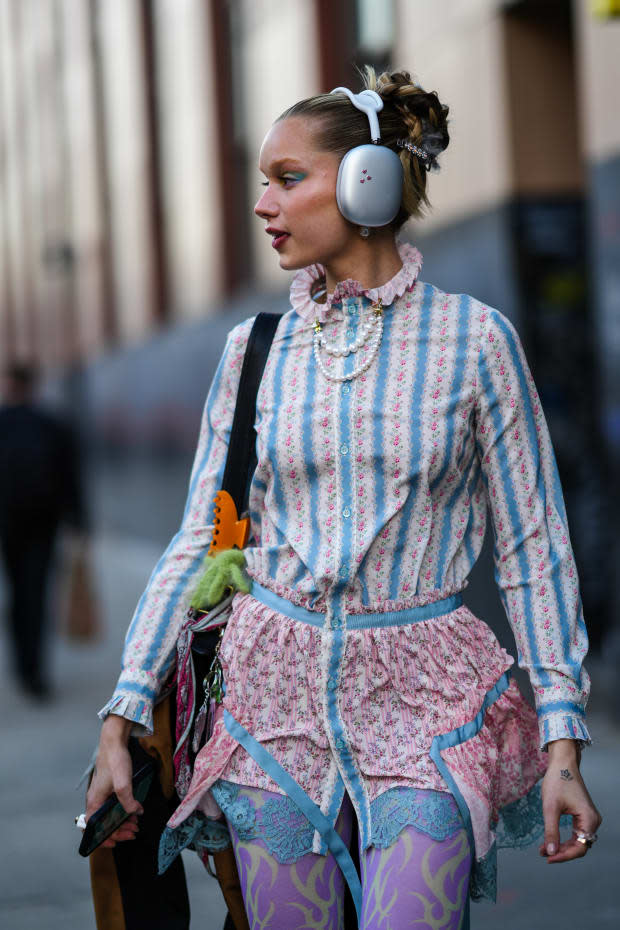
left=100, top=244, right=589, bottom=745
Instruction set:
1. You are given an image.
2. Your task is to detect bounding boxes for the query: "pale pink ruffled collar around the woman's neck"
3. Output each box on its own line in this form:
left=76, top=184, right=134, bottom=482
left=291, top=242, right=422, bottom=323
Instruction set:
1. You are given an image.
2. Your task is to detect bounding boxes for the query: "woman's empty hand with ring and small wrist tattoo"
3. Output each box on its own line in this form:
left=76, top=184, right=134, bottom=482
left=540, top=739, right=602, bottom=863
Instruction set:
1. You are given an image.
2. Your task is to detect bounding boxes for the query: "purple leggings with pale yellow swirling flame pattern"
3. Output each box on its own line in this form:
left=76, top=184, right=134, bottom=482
left=228, top=787, right=471, bottom=930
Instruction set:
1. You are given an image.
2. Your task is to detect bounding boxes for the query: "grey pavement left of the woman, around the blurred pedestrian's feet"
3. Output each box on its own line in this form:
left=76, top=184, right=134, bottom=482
left=0, top=539, right=225, bottom=930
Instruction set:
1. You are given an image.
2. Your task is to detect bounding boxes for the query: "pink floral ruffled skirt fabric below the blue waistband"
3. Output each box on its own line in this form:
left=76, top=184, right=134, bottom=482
left=162, top=594, right=546, bottom=858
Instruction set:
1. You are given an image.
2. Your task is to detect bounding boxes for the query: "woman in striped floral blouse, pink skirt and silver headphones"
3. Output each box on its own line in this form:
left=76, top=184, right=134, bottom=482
left=88, top=69, right=600, bottom=930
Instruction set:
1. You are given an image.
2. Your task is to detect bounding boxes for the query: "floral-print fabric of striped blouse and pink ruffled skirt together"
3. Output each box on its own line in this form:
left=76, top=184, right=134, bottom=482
left=101, top=237, right=589, bottom=876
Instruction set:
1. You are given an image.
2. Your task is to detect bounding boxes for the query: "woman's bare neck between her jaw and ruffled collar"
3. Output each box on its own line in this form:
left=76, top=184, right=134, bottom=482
left=325, top=229, right=403, bottom=293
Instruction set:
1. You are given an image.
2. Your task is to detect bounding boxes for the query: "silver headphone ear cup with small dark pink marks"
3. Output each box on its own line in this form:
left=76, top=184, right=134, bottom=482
left=336, top=145, right=403, bottom=226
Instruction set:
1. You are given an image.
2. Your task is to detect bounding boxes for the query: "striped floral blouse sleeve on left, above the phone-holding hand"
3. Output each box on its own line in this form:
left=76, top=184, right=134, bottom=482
left=99, top=318, right=253, bottom=732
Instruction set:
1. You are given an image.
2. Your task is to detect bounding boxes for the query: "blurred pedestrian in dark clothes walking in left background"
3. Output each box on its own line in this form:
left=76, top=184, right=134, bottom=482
left=0, top=362, right=86, bottom=699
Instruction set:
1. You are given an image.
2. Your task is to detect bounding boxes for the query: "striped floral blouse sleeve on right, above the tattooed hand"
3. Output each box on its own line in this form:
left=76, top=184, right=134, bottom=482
left=476, top=308, right=590, bottom=748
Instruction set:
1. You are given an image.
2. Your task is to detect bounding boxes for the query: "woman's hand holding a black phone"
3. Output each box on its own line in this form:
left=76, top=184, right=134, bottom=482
left=86, top=714, right=143, bottom=848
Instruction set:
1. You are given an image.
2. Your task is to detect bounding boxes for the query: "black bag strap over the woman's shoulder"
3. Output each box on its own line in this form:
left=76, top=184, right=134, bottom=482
left=222, top=313, right=281, bottom=516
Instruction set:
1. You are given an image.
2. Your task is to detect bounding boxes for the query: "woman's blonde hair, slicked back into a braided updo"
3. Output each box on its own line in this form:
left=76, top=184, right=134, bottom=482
left=277, top=65, right=450, bottom=228
